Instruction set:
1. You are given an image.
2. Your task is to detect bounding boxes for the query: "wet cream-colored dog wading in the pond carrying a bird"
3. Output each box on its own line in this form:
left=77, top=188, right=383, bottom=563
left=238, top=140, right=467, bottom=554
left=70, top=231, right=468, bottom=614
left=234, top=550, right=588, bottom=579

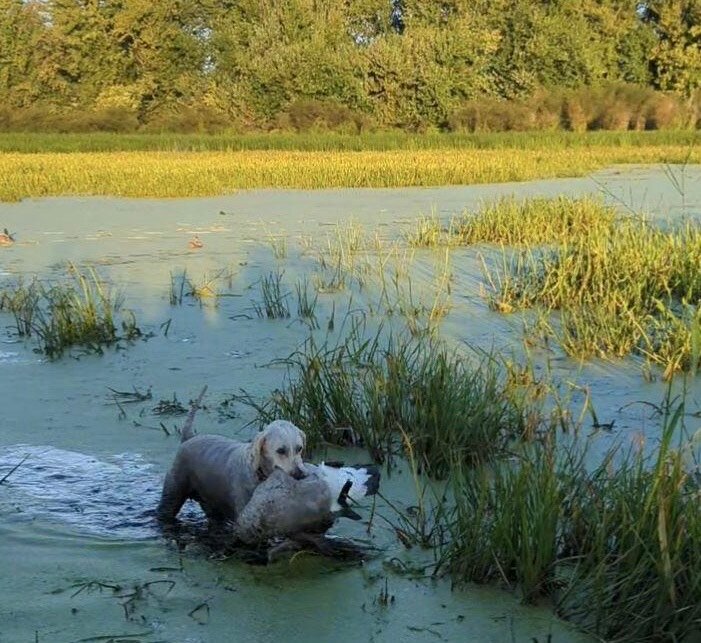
left=157, top=420, right=306, bottom=522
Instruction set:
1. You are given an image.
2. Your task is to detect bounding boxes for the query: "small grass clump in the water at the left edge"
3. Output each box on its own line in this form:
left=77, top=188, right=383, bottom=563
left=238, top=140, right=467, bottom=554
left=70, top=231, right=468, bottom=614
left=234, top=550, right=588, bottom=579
left=0, top=266, right=141, bottom=359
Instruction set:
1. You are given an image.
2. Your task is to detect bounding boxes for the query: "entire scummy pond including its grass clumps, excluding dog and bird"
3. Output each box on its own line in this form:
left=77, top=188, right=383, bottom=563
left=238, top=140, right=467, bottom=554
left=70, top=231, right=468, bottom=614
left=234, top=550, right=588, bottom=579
left=0, top=167, right=701, bottom=642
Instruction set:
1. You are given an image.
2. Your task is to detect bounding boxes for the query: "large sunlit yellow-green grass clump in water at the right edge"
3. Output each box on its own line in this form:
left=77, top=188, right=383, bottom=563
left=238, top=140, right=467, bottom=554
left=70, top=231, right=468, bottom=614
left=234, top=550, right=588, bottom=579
left=483, top=209, right=701, bottom=378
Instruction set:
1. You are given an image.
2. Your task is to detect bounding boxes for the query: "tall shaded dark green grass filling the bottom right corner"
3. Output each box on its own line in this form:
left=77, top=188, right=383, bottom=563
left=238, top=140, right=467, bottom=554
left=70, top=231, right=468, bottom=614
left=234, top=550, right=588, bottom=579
left=447, top=394, right=701, bottom=641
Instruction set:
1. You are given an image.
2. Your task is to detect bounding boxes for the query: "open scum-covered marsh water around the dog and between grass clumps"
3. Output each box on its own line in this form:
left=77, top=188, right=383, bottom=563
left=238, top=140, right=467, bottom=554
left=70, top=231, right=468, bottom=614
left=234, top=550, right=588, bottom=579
left=0, top=167, right=701, bottom=643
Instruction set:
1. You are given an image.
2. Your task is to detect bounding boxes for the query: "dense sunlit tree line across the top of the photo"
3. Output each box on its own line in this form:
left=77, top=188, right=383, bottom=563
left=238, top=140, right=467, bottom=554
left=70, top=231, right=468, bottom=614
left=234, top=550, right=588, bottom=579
left=0, top=0, right=701, bottom=130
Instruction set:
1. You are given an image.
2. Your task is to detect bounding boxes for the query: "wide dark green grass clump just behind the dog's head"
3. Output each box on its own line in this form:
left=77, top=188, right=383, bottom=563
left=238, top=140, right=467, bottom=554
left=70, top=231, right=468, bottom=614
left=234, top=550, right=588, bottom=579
left=232, top=322, right=538, bottom=476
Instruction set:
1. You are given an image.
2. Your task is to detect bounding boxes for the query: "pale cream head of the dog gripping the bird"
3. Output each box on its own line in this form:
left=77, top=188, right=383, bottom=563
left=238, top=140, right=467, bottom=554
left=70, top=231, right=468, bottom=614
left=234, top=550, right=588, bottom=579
left=251, top=420, right=307, bottom=479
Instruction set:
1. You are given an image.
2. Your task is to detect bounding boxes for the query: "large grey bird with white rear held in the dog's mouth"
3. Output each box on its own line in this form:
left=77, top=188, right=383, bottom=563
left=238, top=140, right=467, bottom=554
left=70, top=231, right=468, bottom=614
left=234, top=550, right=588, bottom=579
left=233, top=462, right=380, bottom=545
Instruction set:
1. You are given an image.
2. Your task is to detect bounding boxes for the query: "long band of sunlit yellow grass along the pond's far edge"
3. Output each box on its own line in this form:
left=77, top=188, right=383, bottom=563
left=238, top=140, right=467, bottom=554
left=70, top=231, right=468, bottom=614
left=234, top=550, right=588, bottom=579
left=0, top=144, right=701, bottom=201
